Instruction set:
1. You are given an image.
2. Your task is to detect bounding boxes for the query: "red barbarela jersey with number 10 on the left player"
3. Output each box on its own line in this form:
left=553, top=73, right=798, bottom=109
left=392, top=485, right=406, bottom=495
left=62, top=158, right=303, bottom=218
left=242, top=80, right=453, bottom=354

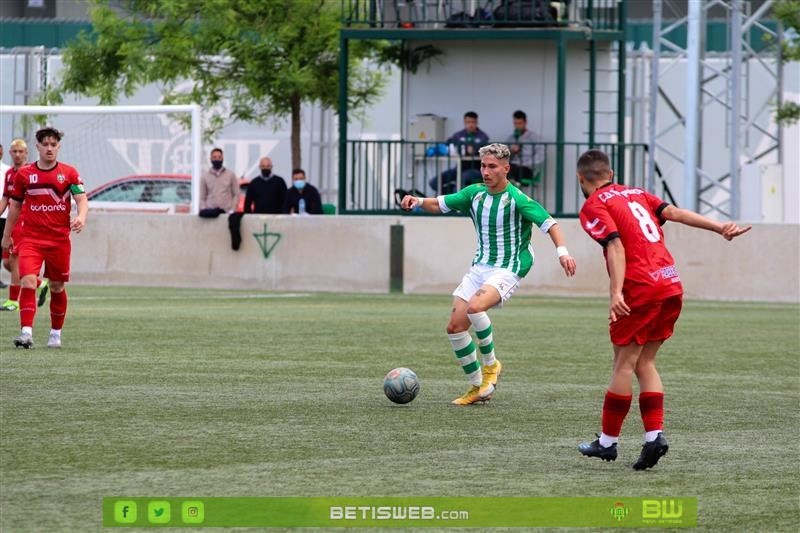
left=11, top=162, right=84, bottom=240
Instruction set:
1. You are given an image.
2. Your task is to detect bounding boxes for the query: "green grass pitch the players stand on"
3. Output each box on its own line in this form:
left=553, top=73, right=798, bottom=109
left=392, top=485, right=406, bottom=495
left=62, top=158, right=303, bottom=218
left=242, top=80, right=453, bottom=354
left=0, top=287, right=800, bottom=531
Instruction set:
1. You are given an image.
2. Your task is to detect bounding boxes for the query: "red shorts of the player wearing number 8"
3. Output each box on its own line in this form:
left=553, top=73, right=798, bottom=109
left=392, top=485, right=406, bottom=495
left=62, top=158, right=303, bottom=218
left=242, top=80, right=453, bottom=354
left=609, top=294, right=683, bottom=346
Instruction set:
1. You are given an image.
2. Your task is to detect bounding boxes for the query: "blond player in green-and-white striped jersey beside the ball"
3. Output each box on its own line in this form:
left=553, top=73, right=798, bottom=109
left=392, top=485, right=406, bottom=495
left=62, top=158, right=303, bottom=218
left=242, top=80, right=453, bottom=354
left=401, top=143, right=575, bottom=405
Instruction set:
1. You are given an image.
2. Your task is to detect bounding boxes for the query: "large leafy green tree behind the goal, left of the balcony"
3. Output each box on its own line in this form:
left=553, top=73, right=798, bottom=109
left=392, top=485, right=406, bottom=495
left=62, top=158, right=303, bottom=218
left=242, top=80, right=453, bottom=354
left=43, top=0, right=386, bottom=167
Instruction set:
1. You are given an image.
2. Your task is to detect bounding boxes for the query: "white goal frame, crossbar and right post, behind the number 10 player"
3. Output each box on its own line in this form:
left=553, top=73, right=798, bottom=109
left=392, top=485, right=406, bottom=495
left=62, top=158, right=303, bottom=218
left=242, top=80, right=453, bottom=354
left=0, top=104, right=203, bottom=215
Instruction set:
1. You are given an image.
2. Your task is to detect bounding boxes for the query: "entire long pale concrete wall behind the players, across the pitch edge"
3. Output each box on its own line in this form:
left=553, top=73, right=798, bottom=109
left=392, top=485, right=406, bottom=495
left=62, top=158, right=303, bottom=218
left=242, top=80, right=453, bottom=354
left=72, top=213, right=800, bottom=302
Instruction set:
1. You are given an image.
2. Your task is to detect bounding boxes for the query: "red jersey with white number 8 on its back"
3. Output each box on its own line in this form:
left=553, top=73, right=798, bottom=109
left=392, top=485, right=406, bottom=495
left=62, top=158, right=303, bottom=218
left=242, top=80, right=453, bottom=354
left=580, top=184, right=683, bottom=307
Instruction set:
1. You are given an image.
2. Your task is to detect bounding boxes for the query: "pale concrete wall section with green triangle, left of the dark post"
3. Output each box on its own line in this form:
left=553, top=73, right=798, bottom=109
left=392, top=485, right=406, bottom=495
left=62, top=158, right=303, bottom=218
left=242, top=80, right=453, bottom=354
left=72, top=213, right=389, bottom=292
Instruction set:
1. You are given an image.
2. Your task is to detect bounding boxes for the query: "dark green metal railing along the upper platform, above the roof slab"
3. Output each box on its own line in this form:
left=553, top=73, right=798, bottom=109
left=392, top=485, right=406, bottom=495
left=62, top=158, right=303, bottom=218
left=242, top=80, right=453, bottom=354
left=341, top=0, right=625, bottom=30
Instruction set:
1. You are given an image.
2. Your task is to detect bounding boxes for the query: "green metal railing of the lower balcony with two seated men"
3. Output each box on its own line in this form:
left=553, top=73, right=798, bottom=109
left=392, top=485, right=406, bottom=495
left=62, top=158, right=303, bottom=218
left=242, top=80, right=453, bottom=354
left=340, top=140, right=648, bottom=217
